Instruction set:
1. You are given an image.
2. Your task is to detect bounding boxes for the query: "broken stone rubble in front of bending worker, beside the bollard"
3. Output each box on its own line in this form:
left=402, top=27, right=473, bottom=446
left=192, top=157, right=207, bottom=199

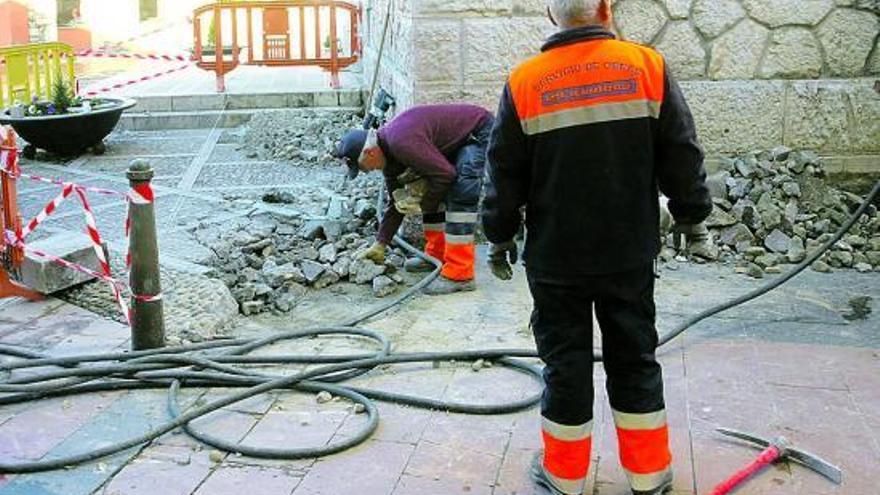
left=192, top=180, right=414, bottom=315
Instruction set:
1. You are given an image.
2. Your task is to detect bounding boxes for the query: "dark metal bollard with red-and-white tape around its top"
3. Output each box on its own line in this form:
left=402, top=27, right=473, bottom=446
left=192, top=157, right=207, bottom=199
left=126, top=159, right=165, bottom=351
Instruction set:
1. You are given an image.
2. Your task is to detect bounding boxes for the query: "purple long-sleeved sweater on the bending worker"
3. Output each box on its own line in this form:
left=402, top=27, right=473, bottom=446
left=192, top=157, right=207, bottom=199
left=377, top=104, right=491, bottom=244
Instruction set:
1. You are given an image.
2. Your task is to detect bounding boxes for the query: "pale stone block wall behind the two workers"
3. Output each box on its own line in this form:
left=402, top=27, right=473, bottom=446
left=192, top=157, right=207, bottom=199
left=364, top=0, right=880, bottom=172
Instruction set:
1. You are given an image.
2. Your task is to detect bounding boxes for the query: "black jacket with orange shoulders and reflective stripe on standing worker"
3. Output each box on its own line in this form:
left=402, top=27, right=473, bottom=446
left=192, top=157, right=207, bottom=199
left=482, top=27, right=712, bottom=277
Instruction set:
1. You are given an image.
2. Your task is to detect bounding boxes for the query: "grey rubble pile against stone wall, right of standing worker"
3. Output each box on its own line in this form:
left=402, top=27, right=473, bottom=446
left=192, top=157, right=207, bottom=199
left=688, top=147, right=880, bottom=277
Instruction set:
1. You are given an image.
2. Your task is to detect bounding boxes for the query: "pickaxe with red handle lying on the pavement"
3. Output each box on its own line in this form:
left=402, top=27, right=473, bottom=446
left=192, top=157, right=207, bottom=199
left=711, top=428, right=843, bottom=495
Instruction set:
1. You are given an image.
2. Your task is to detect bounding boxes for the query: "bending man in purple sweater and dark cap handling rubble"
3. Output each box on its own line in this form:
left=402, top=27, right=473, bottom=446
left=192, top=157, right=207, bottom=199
left=336, top=104, right=493, bottom=294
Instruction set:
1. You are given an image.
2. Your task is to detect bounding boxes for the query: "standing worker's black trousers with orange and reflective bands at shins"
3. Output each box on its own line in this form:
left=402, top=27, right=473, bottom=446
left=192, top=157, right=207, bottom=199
left=526, top=263, right=672, bottom=494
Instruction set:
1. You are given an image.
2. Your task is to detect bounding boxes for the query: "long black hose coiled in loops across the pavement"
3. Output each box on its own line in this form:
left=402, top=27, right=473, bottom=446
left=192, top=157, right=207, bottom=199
left=0, top=181, right=880, bottom=473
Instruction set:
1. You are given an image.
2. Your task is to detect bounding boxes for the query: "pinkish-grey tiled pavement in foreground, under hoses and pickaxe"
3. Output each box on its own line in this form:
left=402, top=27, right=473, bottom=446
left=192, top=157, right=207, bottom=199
left=0, top=258, right=880, bottom=495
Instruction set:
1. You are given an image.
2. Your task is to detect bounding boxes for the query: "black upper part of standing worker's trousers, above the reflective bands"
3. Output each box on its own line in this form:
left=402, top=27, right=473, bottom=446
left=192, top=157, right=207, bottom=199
left=526, top=263, right=664, bottom=425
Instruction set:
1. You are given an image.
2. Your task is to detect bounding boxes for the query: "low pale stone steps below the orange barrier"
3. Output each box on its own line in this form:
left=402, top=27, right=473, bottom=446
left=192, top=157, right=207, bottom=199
left=116, top=89, right=364, bottom=131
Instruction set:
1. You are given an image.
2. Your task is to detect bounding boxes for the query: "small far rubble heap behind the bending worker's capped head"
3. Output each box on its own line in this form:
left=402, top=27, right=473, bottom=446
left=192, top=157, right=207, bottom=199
left=243, top=109, right=361, bottom=167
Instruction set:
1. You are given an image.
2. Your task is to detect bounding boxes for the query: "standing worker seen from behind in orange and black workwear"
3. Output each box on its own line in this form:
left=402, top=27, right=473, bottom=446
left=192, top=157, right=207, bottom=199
left=482, top=0, right=712, bottom=495
